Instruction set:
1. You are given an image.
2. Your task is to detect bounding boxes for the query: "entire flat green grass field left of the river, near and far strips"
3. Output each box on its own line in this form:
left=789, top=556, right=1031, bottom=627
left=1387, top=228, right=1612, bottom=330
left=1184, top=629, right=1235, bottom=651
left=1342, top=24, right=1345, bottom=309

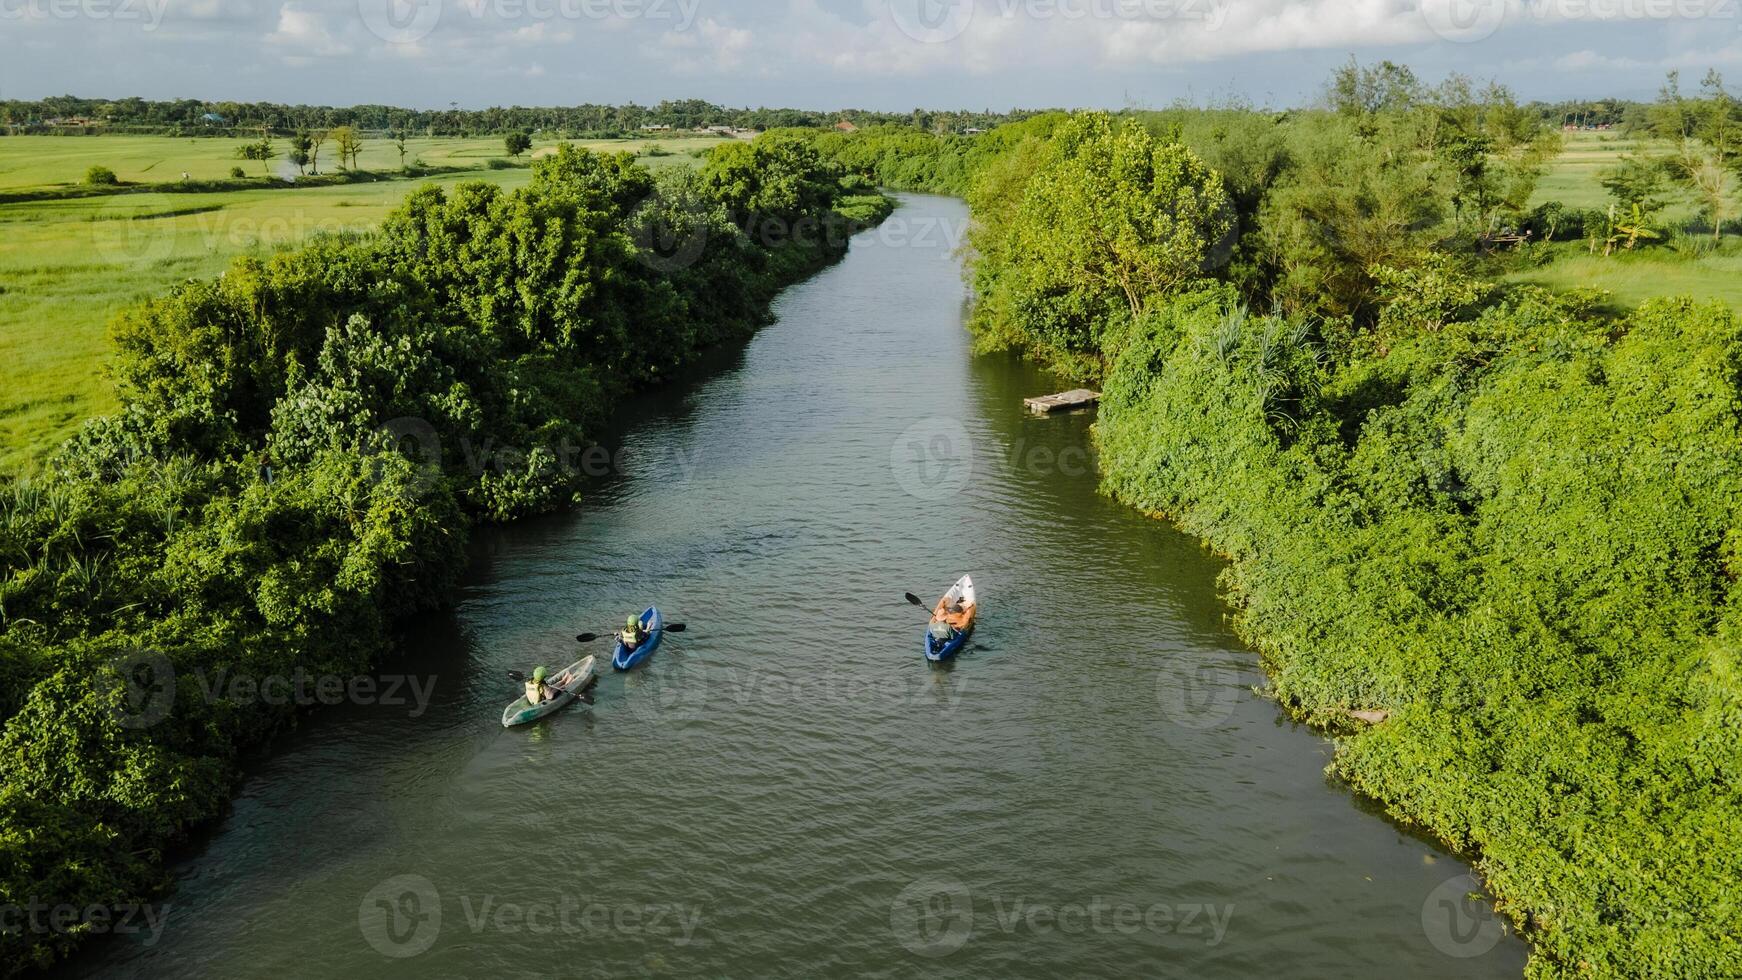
left=0, top=136, right=719, bottom=472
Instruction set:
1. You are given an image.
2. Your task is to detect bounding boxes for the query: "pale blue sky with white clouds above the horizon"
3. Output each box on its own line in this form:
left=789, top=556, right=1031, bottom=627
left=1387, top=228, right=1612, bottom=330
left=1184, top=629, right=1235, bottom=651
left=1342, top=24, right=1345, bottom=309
left=0, top=0, right=1742, bottom=111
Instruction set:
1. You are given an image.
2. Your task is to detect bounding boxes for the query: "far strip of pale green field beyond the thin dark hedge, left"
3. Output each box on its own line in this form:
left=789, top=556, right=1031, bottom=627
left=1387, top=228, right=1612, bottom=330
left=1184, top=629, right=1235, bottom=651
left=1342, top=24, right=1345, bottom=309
left=0, top=136, right=719, bottom=190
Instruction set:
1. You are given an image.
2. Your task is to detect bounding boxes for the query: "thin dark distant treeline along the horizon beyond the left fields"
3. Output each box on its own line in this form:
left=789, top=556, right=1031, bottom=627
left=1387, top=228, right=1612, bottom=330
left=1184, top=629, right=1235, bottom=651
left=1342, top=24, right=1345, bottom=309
left=0, top=96, right=1033, bottom=138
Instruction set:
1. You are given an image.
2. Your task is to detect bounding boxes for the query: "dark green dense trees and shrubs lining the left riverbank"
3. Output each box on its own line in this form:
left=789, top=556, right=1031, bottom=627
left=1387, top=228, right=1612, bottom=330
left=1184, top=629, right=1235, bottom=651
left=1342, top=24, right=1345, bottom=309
left=0, top=136, right=892, bottom=975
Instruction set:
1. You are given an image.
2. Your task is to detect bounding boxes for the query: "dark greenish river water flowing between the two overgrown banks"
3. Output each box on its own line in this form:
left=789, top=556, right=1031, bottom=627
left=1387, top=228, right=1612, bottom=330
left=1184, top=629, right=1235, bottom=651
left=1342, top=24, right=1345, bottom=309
left=75, top=197, right=1524, bottom=978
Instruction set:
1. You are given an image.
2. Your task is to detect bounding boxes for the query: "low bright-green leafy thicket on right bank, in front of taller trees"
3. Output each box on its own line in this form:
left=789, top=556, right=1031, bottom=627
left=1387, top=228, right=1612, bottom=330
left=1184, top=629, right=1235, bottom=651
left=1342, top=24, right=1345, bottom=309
left=1097, top=282, right=1742, bottom=977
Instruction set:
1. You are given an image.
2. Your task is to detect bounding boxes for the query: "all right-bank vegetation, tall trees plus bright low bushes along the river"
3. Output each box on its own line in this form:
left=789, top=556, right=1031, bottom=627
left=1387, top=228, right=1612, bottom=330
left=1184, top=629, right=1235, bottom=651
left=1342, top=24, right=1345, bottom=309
left=819, top=66, right=1742, bottom=977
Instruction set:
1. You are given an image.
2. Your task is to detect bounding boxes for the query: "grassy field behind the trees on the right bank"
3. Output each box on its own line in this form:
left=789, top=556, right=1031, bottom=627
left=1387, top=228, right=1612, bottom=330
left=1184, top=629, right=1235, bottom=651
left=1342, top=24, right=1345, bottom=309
left=1507, top=132, right=1742, bottom=308
